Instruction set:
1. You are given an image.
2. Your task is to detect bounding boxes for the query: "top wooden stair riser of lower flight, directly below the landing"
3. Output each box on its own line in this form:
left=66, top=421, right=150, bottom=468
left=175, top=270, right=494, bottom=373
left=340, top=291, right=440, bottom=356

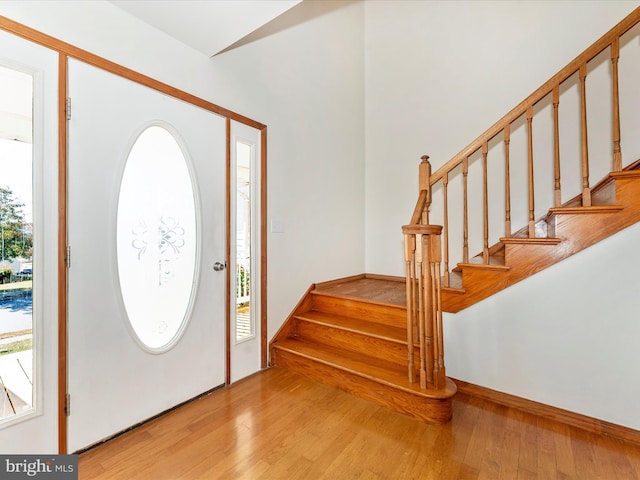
left=312, top=294, right=407, bottom=328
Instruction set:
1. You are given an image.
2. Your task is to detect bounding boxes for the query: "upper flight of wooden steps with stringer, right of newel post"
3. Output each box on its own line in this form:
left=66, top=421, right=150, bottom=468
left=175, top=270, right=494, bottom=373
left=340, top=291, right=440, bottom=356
left=442, top=161, right=640, bottom=313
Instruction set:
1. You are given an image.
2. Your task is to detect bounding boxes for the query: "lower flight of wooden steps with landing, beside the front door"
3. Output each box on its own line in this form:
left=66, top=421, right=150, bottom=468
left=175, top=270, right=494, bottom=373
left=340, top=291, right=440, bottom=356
left=270, top=275, right=456, bottom=423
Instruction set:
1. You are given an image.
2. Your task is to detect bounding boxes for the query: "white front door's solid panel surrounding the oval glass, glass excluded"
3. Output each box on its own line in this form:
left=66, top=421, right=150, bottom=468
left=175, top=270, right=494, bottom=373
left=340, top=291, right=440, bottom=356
left=68, top=60, right=226, bottom=452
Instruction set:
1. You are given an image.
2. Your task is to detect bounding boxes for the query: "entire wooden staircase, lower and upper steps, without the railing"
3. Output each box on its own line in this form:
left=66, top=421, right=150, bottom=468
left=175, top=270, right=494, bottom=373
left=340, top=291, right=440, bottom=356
left=270, top=161, right=640, bottom=424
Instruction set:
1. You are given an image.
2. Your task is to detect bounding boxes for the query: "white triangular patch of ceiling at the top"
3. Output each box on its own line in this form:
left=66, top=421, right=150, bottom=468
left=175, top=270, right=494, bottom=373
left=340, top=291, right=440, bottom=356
left=110, top=0, right=302, bottom=57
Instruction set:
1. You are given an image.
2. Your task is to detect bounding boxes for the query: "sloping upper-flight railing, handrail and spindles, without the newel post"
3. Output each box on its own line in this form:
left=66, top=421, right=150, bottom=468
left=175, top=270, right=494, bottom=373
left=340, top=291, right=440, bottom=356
left=429, top=8, right=640, bottom=287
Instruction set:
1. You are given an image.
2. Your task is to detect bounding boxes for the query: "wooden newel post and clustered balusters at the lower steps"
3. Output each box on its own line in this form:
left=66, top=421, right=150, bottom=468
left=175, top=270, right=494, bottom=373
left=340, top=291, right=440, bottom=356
left=402, top=156, right=446, bottom=389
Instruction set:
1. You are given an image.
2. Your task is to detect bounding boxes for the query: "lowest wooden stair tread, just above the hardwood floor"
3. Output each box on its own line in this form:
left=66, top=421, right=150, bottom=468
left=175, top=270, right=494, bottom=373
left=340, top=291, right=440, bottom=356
left=274, top=337, right=450, bottom=398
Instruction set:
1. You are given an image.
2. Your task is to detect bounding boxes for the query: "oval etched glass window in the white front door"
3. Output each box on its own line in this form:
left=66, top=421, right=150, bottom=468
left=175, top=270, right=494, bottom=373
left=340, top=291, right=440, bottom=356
left=116, top=124, right=197, bottom=353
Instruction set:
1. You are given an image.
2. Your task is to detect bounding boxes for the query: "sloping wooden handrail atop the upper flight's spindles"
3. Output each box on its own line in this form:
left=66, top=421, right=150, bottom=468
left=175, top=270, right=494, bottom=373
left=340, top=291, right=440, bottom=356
left=430, top=7, right=640, bottom=185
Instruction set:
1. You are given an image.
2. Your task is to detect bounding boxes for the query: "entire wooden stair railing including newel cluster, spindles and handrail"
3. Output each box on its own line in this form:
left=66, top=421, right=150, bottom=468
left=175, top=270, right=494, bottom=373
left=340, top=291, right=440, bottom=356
left=403, top=7, right=640, bottom=388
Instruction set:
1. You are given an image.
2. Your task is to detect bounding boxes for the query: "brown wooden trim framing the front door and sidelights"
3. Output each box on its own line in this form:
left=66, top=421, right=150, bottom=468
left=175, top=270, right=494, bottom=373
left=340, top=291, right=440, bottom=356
left=0, top=15, right=267, bottom=454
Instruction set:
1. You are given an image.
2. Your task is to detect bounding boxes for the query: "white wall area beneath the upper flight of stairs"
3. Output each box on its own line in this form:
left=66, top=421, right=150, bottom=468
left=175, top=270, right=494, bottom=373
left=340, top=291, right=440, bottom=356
left=444, top=224, right=640, bottom=430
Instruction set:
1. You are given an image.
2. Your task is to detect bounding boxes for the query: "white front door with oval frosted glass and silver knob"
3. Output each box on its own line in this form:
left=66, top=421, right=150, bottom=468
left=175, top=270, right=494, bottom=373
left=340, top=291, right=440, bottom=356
left=68, top=61, right=226, bottom=452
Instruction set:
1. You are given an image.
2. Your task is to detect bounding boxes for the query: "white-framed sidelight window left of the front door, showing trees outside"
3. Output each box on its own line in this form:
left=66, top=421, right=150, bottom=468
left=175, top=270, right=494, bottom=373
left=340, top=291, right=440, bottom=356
left=0, top=32, right=58, bottom=454
